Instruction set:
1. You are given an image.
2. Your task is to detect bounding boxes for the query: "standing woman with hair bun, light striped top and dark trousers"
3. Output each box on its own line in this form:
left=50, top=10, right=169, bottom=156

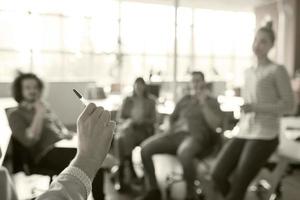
left=212, top=22, right=294, bottom=200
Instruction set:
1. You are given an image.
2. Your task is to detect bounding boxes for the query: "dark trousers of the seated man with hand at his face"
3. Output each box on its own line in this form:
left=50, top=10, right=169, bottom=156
left=141, top=132, right=216, bottom=194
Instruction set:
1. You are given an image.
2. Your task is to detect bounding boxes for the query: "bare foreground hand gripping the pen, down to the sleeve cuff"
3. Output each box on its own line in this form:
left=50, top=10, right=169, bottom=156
left=73, top=103, right=116, bottom=178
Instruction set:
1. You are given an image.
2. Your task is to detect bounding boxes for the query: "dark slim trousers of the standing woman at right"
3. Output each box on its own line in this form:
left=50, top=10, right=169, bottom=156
left=212, top=138, right=278, bottom=200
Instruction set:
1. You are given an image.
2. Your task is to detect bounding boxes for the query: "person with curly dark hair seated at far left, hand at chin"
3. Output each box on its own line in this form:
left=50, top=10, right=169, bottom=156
left=9, top=73, right=104, bottom=199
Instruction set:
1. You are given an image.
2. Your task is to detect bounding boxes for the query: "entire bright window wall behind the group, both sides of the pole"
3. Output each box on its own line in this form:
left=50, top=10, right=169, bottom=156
left=0, top=0, right=255, bottom=87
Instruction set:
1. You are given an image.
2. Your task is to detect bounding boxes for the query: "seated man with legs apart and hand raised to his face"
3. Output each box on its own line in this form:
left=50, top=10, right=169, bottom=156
left=140, top=71, right=223, bottom=200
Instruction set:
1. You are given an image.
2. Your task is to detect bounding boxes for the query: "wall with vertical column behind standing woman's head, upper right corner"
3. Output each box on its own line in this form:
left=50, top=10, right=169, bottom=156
left=255, top=0, right=300, bottom=76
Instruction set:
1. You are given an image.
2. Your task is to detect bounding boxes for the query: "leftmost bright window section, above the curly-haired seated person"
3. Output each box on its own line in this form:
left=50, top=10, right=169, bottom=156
left=0, top=0, right=118, bottom=84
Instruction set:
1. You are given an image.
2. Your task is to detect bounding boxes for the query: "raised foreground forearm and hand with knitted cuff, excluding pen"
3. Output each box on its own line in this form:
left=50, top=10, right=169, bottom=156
left=38, top=103, right=115, bottom=200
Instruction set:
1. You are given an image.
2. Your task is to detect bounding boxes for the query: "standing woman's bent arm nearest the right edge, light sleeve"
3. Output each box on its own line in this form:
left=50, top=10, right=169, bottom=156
left=253, top=66, right=295, bottom=115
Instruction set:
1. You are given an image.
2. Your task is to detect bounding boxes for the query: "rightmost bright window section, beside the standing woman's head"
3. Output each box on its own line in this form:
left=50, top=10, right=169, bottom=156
left=194, top=9, right=255, bottom=84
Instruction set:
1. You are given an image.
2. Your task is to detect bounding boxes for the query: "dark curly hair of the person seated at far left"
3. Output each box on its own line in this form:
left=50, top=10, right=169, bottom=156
left=12, top=73, right=44, bottom=103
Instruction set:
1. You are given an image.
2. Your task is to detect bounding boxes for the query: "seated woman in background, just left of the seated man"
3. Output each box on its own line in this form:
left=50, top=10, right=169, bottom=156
left=115, top=78, right=156, bottom=190
